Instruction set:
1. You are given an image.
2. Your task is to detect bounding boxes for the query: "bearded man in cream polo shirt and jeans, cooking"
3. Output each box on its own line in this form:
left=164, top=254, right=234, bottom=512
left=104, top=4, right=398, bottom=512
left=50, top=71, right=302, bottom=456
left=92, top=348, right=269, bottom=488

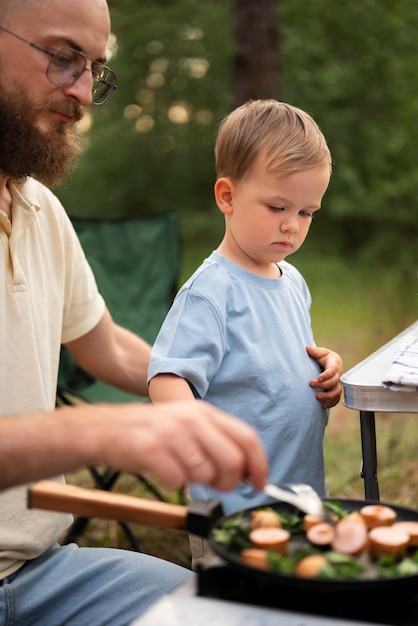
left=0, top=0, right=267, bottom=626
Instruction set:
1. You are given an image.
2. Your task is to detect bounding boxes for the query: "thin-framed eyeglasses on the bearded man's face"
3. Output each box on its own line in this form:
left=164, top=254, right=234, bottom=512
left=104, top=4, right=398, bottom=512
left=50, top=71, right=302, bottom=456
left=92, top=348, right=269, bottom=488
left=0, top=26, right=116, bottom=104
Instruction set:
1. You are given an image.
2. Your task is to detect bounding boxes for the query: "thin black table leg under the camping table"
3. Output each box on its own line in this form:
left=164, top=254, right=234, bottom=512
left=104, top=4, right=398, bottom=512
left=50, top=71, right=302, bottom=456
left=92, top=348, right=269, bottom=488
left=360, top=411, right=379, bottom=501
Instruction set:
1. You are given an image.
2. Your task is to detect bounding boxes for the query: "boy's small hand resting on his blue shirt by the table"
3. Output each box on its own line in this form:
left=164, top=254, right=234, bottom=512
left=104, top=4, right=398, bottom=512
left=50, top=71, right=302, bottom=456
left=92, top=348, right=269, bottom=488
left=306, top=346, right=343, bottom=409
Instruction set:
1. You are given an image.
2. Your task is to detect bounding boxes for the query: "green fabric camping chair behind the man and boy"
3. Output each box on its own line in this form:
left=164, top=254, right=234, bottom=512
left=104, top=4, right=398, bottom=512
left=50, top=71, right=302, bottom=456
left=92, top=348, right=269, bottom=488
left=57, top=211, right=180, bottom=550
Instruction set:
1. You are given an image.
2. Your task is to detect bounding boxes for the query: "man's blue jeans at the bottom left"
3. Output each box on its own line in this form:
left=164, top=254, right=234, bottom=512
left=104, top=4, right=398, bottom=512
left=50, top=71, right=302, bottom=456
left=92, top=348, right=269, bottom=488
left=0, top=544, right=193, bottom=626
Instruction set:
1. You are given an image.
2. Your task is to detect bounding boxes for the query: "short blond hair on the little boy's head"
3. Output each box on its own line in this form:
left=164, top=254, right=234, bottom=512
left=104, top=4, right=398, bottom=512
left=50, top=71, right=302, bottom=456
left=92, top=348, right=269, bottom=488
left=215, top=100, right=332, bottom=180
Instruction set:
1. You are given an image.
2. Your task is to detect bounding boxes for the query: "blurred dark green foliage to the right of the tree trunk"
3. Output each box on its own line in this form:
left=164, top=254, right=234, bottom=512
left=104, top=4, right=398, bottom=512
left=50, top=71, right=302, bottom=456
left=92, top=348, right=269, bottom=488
left=281, top=0, right=418, bottom=264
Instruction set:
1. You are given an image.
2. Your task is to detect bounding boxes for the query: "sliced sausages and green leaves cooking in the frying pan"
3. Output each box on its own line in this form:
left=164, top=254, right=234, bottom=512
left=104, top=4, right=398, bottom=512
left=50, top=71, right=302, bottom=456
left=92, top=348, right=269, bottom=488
left=212, top=501, right=418, bottom=580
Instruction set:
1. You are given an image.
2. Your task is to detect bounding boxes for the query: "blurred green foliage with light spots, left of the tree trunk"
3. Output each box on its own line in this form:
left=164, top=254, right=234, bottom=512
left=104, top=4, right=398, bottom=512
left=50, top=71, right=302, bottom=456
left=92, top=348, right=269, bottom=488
left=59, top=0, right=233, bottom=232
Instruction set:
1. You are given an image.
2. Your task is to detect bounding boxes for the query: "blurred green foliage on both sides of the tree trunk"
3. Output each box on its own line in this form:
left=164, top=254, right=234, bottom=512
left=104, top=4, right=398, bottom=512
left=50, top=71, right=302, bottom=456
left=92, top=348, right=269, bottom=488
left=58, top=0, right=418, bottom=272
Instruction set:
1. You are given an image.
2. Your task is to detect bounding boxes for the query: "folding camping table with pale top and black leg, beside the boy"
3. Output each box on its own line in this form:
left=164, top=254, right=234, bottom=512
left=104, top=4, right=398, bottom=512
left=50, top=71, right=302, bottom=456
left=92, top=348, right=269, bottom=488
left=341, top=320, right=418, bottom=500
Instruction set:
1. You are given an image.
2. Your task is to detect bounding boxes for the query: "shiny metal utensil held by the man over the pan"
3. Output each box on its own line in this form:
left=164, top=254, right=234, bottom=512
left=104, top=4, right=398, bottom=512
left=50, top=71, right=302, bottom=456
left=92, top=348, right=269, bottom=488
left=263, top=483, right=335, bottom=526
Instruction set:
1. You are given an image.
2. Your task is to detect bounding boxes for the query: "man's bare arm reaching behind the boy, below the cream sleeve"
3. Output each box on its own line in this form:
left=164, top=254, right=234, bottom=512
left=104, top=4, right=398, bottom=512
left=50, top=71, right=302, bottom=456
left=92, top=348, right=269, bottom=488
left=65, top=309, right=151, bottom=396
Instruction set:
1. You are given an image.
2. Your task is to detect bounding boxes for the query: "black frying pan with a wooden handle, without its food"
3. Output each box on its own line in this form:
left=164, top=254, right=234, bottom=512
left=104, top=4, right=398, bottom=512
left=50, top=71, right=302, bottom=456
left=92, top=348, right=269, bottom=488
left=28, top=481, right=418, bottom=588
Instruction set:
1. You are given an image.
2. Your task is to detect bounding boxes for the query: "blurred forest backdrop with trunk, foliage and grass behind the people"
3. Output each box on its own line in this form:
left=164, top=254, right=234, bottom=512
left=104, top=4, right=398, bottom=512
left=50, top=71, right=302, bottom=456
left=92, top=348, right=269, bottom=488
left=61, top=0, right=418, bottom=558
